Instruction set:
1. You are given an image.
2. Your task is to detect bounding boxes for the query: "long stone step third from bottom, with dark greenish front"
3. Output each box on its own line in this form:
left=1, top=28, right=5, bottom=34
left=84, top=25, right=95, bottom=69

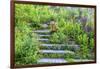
left=40, top=44, right=80, bottom=51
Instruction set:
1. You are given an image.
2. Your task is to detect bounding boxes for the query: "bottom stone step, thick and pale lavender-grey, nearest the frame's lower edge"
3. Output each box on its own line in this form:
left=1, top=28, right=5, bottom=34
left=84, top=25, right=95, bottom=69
left=37, top=58, right=67, bottom=63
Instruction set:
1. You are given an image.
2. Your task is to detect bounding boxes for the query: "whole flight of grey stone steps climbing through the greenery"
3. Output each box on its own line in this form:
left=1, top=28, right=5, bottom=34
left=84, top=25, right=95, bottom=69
left=34, top=24, right=93, bottom=63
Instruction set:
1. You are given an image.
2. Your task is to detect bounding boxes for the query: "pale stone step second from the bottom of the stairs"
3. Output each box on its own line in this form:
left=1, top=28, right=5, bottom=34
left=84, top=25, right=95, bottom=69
left=39, top=50, right=74, bottom=54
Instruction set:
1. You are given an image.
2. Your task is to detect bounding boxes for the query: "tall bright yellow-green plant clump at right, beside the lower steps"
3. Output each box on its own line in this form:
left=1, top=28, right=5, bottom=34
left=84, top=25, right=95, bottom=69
left=77, top=34, right=89, bottom=58
